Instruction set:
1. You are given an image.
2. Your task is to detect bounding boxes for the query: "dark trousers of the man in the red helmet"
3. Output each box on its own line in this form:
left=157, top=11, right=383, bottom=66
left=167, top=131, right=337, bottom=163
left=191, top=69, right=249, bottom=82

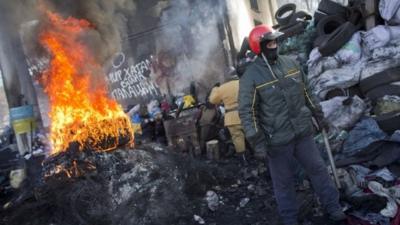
left=267, top=136, right=341, bottom=225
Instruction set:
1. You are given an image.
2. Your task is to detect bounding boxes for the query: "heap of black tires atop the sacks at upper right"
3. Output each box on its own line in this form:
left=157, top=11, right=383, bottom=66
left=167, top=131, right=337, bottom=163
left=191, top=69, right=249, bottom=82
left=314, top=0, right=365, bottom=56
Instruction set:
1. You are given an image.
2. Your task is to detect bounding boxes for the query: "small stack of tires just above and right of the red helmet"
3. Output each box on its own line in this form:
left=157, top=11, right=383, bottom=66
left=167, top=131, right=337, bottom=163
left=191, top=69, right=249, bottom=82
left=274, top=3, right=312, bottom=39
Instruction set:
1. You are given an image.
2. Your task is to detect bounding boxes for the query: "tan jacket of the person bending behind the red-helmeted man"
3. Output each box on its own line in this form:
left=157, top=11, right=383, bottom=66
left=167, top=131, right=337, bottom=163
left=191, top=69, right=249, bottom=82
left=209, top=80, right=241, bottom=126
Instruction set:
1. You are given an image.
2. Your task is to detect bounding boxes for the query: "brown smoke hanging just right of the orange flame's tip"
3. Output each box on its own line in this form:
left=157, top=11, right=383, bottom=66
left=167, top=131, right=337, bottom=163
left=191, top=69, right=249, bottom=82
left=42, top=0, right=136, bottom=64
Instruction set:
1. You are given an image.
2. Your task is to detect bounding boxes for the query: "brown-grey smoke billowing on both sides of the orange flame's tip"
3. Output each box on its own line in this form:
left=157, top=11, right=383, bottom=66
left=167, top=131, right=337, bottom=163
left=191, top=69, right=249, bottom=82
left=0, top=0, right=136, bottom=75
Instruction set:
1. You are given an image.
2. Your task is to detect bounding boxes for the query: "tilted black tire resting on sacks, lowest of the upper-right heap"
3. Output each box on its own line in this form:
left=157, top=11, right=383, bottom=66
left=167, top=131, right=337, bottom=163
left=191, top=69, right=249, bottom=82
left=318, top=22, right=358, bottom=56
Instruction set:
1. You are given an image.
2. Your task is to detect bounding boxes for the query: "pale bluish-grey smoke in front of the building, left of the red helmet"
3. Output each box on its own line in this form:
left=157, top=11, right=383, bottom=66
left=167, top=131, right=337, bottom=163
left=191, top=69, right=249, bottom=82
left=157, top=0, right=226, bottom=98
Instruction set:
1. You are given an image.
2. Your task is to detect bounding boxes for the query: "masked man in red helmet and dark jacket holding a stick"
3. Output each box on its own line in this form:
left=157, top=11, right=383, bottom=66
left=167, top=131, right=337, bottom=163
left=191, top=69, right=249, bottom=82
left=239, top=25, right=346, bottom=225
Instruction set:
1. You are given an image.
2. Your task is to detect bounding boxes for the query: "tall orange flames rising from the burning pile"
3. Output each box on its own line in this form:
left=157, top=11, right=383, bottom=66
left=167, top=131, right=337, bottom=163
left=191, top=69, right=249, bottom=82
left=39, top=12, right=133, bottom=154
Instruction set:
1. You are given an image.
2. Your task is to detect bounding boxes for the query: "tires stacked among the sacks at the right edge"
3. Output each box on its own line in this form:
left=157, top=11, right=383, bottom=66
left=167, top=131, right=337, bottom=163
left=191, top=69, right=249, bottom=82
left=359, top=67, right=400, bottom=133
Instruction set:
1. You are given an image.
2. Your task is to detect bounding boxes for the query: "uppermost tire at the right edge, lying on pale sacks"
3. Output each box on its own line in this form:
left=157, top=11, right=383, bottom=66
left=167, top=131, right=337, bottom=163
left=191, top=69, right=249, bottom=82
left=360, top=67, right=400, bottom=93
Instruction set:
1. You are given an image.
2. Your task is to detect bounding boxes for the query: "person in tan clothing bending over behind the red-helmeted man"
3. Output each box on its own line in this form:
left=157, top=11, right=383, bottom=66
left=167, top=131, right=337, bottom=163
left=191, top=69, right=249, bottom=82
left=209, top=68, right=247, bottom=164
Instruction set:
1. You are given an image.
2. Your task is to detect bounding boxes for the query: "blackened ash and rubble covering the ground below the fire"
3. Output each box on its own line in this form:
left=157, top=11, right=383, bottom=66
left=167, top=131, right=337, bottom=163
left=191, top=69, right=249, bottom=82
left=0, top=142, right=340, bottom=225
